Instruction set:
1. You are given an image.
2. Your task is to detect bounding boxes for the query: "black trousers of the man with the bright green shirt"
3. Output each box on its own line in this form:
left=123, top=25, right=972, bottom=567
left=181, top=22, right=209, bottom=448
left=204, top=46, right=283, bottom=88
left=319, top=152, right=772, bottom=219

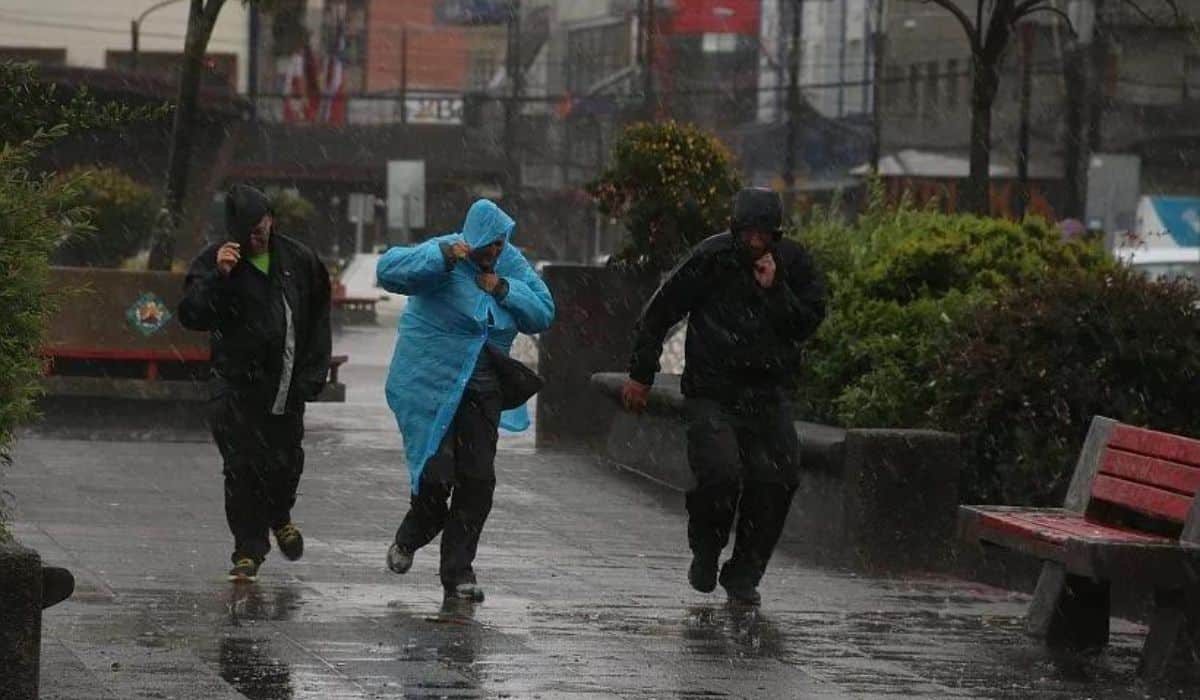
left=209, top=393, right=304, bottom=562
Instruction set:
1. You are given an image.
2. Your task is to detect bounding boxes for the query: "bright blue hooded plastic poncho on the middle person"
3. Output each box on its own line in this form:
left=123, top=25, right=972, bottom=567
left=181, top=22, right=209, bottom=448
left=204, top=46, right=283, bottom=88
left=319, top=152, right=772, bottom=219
left=376, top=199, right=554, bottom=493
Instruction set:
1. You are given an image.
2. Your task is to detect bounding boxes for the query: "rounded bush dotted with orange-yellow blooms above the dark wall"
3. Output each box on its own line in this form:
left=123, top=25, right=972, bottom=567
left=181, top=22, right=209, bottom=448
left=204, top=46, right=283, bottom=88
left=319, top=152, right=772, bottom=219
left=588, top=121, right=742, bottom=271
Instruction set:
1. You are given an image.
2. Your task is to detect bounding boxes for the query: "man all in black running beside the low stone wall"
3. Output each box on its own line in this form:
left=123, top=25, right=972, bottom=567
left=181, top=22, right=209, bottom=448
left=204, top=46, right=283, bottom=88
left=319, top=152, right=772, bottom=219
left=623, top=189, right=824, bottom=605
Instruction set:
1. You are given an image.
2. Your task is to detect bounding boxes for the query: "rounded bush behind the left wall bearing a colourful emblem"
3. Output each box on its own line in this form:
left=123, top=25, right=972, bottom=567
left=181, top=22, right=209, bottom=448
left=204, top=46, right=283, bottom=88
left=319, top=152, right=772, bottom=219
left=52, top=167, right=158, bottom=268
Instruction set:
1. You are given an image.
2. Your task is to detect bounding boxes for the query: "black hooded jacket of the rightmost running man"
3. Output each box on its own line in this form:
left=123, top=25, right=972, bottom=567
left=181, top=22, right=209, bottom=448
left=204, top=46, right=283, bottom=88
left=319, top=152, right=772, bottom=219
left=629, top=190, right=826, bottom=401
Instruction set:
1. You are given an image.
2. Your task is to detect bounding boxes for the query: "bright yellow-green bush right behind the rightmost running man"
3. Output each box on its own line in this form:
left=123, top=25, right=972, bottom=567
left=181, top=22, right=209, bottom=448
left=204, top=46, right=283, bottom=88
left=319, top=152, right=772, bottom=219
left=798, top=193, right=1110, bottom=427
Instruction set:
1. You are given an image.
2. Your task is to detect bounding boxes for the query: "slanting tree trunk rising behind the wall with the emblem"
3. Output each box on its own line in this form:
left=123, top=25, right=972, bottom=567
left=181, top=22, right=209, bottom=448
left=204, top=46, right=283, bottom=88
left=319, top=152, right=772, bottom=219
left=149, top=0, right=224, bottom=270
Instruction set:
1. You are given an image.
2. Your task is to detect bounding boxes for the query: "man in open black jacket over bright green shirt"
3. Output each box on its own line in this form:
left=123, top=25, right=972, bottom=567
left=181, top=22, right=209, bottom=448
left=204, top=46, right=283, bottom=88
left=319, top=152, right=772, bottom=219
left=179, top=185, right=331, bottom=581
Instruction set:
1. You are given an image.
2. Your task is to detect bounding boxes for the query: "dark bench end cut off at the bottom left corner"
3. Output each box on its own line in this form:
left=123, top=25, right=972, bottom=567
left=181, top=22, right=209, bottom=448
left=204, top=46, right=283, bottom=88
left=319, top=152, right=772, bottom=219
left=0, top=543, right=74, bottom=700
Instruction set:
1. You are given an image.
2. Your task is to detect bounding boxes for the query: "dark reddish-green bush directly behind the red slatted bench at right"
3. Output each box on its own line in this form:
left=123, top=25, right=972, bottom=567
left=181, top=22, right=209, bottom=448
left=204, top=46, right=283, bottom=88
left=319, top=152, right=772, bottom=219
left=937, top=268, right=1200, bottom=505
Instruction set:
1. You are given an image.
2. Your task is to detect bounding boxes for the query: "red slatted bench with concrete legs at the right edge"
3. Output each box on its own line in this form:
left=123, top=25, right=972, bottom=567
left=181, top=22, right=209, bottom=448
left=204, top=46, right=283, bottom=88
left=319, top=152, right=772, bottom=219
left=959, top=417, right=1200, bottom=678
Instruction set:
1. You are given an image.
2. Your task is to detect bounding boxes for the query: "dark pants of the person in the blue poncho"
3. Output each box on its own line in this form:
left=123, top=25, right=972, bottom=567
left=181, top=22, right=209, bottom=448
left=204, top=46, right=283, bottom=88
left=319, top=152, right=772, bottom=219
left=396, top=390, right=500, bottom=590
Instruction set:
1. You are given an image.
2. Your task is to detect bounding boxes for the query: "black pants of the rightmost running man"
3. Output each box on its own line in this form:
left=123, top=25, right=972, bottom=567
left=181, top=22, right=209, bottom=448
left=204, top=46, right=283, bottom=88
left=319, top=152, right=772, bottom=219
left=688, top=399, right=799, bottom=587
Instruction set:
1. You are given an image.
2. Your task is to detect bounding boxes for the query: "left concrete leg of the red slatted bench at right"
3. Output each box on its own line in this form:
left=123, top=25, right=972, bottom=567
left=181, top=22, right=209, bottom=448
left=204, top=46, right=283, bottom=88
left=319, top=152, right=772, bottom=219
left=1025, top=562, right=1110, bottom=648
